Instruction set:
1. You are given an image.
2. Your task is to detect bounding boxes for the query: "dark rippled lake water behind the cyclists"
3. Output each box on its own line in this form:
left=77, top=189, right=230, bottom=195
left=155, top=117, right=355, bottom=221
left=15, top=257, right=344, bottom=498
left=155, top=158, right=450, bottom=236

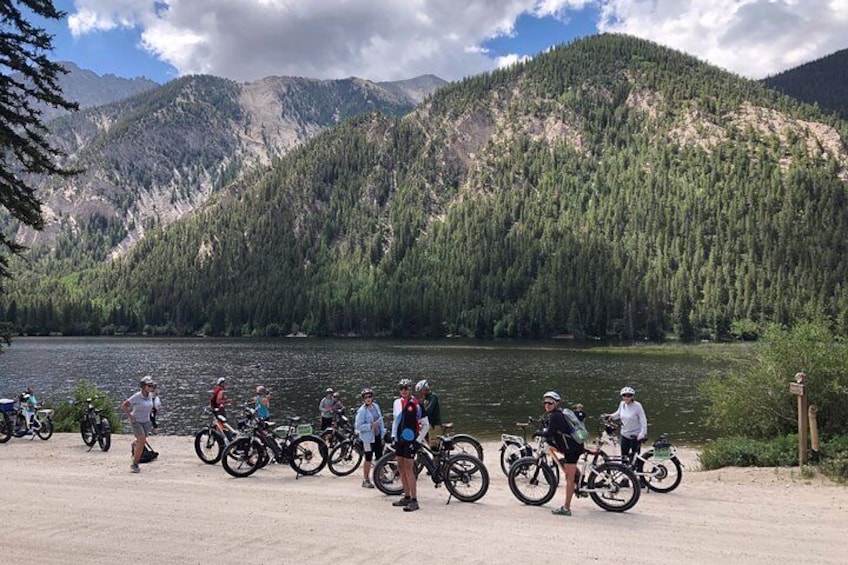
left=0, top=338, right=726, bottom=444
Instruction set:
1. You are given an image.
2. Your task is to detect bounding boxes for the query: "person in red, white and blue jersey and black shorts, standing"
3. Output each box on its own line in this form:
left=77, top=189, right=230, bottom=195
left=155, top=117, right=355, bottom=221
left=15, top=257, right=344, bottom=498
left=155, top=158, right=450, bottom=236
left=392, top=379, right=430, bottom=512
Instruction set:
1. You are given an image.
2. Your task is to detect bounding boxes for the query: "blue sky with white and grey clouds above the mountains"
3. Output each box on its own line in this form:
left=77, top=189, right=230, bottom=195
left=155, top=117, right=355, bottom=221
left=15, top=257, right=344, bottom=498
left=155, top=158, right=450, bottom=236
left=36, top=0, right=848, bottom=83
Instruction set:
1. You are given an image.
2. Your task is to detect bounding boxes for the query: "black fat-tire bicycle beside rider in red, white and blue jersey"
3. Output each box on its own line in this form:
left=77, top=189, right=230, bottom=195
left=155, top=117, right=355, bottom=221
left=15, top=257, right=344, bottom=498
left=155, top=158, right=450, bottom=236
left=372, top=436, right=489, bottom=504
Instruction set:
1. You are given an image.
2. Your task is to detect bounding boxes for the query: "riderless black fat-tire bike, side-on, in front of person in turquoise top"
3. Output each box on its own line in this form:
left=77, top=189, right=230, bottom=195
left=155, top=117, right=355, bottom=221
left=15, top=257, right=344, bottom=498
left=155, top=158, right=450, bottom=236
left=222, top=409, right=327, bottom=478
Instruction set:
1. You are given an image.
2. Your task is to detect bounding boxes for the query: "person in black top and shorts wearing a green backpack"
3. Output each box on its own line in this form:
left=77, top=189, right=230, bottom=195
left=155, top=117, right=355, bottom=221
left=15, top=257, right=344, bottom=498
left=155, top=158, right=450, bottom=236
left=542, top=390, right=586, bottom=516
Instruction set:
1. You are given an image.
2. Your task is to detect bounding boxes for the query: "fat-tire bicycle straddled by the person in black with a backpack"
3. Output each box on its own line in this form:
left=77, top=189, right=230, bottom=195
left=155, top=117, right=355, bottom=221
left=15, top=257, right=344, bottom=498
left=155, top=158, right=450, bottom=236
left=508, top=432, right=641, bottom=512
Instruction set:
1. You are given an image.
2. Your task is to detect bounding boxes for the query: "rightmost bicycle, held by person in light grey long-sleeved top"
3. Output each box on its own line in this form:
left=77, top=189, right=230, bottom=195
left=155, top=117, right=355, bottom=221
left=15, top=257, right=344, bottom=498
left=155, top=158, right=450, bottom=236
left=599, top=418, right=683, bottom=493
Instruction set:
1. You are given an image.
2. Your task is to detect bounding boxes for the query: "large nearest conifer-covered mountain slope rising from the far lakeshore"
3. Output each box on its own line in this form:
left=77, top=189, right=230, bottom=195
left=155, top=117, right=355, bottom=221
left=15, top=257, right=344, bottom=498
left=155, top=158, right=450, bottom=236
left=6, top=35, right=848, bottom=339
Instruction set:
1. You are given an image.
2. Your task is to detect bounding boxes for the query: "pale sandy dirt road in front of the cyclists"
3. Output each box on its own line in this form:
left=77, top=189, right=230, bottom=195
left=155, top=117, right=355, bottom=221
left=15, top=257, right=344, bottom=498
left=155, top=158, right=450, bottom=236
left=0, top=434, right=848, bottom=565
